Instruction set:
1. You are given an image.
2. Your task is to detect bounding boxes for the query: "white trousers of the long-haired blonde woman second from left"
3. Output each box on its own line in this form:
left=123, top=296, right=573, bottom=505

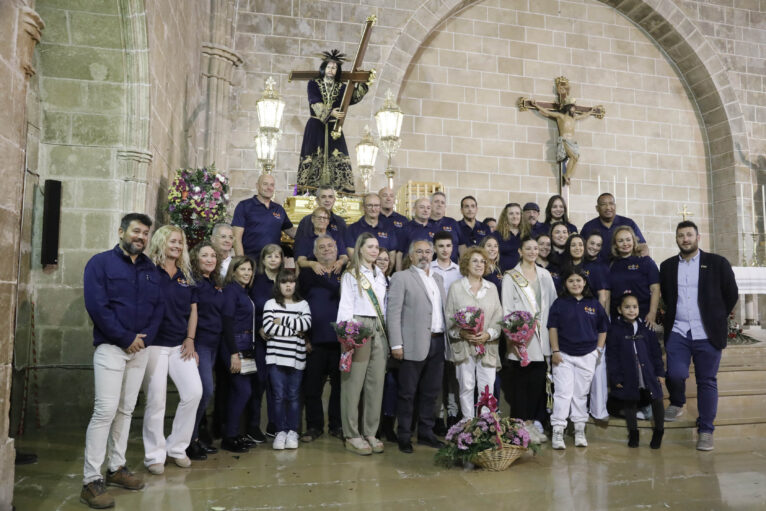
left=144, top=346, right=202, bottom=467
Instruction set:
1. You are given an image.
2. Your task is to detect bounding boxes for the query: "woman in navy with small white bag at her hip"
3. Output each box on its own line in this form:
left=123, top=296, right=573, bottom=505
left=221, top=256, right=265, bottom=452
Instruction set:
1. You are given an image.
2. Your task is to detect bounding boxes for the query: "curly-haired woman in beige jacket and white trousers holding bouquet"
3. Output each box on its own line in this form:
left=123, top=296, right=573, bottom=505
left=445, top=247, right=503, bottom=418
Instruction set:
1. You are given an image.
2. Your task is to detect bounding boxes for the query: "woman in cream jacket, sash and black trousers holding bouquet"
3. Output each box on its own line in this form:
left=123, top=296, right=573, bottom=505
left=503, top=237, right=557, bottom=442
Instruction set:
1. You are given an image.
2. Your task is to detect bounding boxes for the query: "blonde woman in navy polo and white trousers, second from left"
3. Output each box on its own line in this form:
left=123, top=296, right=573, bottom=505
left=143, top=225, right=202, bottom=475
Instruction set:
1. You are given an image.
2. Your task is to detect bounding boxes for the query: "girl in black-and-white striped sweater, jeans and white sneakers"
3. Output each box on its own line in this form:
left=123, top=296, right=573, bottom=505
left=263, top=269, right=311, bottom=449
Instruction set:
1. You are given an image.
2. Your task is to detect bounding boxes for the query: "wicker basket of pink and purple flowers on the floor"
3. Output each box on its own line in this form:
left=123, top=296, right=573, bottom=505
left=436, top=386, right=540, bottom=471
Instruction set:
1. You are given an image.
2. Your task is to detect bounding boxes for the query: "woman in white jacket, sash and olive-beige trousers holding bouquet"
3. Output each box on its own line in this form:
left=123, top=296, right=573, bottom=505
left=337, top=232, right=389, bottom=456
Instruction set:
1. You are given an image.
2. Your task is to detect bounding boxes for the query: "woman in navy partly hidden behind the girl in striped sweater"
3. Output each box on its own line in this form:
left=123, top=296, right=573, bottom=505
left=245, top=243, right=285, bottom=444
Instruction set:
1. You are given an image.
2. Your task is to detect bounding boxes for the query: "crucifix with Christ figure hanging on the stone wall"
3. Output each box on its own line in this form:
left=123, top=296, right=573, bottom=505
left=516, top=76, right=606, bottom=194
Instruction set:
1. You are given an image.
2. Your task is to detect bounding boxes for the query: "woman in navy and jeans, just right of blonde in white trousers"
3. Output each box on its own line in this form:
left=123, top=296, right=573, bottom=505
left=186, top=242, right=223, bottom=460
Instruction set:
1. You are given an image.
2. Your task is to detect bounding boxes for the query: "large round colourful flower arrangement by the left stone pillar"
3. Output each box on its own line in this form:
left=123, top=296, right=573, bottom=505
left=168, top=165, right=229, bottom=249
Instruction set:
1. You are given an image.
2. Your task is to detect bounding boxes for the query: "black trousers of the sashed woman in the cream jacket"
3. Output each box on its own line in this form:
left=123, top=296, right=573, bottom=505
left=504, top=360, right=547, bottom=423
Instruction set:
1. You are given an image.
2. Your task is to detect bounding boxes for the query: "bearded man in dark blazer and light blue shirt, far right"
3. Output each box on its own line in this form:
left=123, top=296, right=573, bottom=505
left=660, top=220, right=738, bottom=451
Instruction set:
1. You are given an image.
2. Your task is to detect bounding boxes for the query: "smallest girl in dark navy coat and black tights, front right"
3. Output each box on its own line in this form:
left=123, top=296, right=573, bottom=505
left=606, top=294, right=665, bottom=449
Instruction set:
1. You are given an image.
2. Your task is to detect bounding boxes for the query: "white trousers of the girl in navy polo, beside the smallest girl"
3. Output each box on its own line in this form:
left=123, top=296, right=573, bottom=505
left=551, top=350, right=598, bottom=427
